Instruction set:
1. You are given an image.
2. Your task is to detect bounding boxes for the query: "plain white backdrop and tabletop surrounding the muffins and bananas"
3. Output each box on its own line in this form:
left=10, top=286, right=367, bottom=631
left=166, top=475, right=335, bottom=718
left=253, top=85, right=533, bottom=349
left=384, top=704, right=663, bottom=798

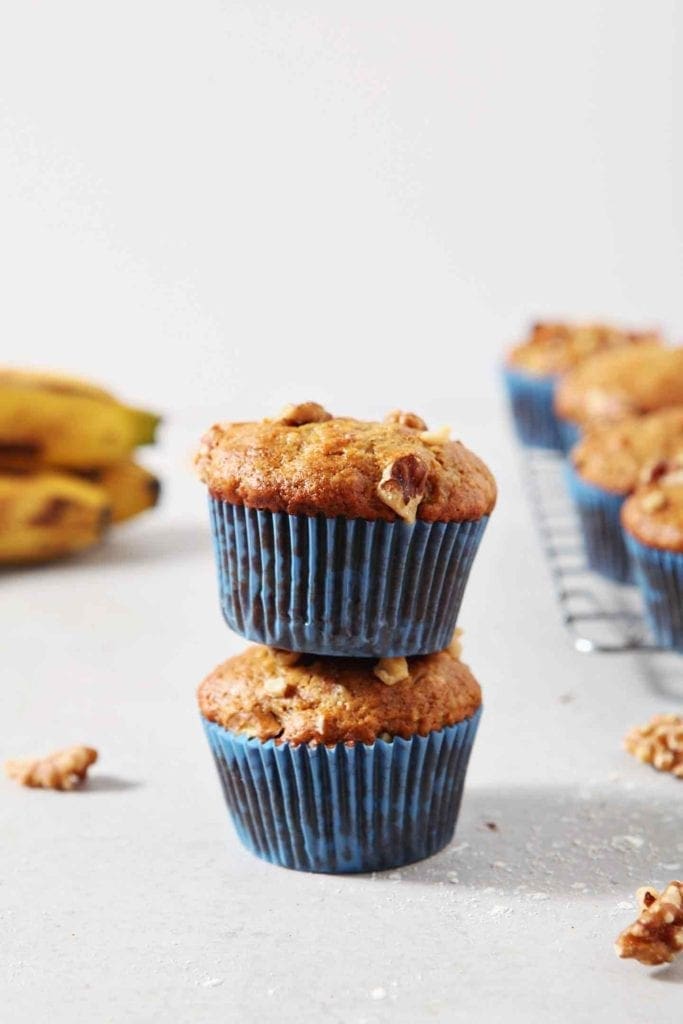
left=0, top=0, right=683, bottom=1024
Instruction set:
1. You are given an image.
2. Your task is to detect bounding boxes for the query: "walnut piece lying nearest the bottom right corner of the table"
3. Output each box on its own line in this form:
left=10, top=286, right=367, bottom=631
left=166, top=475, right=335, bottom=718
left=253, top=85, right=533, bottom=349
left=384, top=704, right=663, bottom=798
left=614, top=882, right=683, bottom=967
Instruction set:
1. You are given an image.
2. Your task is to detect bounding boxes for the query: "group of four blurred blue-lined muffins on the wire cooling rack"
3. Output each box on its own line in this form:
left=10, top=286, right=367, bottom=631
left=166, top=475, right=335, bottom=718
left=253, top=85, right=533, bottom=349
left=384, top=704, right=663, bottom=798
left=505, top=324, right=683, bottom=649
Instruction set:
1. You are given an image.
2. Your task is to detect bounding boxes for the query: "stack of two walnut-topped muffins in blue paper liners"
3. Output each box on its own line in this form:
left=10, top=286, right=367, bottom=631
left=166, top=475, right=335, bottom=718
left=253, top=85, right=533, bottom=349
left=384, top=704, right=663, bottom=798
left=192, top=402, right=496, bottom=871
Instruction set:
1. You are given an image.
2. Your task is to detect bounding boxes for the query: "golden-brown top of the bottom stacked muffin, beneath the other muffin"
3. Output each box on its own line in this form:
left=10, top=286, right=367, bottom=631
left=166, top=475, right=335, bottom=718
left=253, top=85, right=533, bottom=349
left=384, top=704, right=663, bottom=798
left=198, top=645, right=481, bottom=744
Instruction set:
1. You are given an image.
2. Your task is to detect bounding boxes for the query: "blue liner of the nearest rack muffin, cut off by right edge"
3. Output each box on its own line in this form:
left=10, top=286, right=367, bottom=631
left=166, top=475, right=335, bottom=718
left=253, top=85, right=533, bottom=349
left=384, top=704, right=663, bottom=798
left=625, top=532, right=683, bottom=652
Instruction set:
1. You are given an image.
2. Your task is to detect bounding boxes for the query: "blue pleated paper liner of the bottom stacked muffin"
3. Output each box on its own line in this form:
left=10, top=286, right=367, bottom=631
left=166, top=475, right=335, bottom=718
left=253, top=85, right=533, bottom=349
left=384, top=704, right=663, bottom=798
left=202, top=708, right=481, bottom=873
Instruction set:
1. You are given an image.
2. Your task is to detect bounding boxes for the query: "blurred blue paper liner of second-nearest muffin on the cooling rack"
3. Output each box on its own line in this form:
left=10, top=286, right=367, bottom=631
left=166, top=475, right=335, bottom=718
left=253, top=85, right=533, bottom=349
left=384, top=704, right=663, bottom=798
left=565, top=463, right=633, bottom=583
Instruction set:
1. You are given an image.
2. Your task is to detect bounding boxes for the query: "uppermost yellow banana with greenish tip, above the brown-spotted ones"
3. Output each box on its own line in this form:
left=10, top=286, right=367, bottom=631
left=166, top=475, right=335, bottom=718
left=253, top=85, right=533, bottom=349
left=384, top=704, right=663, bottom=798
left=0, top=370, right=159, bottom=469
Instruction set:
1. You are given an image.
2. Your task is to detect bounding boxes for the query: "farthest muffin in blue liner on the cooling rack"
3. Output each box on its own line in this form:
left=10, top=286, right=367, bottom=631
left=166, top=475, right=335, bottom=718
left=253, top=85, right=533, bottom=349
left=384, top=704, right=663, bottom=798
left=504, top=323, right=657, bottom=451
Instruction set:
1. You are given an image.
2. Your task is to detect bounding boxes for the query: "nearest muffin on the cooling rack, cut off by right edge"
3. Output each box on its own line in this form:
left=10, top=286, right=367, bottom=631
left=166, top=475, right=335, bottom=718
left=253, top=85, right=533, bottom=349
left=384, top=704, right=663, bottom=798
left=622, top=477, right=683, bottom=651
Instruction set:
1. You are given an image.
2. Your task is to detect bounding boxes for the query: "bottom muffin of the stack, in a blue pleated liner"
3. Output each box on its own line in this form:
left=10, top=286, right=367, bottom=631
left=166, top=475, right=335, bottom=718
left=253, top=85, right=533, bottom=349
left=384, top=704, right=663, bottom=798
left=198, top=645, right=481, bottom=872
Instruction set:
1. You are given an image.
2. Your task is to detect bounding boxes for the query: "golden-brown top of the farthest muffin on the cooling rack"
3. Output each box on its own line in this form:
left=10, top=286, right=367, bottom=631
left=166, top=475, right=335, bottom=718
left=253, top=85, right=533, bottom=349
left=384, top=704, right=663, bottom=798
left=507, top=322, right=659, bottom=377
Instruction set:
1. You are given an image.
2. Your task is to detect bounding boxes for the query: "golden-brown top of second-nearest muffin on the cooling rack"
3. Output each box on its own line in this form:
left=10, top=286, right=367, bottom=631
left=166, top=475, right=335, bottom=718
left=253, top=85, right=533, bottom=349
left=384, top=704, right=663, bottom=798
left=571, top=406, right=683, bottom=495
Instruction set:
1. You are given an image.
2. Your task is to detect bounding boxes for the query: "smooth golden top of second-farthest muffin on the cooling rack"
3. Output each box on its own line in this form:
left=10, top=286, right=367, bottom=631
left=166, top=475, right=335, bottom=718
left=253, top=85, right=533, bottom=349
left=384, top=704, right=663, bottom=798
left=555, top=344, right=683, bottom=426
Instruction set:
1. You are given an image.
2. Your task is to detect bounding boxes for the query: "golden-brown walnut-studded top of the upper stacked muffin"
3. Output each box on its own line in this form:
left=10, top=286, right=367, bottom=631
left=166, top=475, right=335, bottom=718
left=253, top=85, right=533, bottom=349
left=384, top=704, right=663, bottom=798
left=196, top=402, right=496, bottom=522
